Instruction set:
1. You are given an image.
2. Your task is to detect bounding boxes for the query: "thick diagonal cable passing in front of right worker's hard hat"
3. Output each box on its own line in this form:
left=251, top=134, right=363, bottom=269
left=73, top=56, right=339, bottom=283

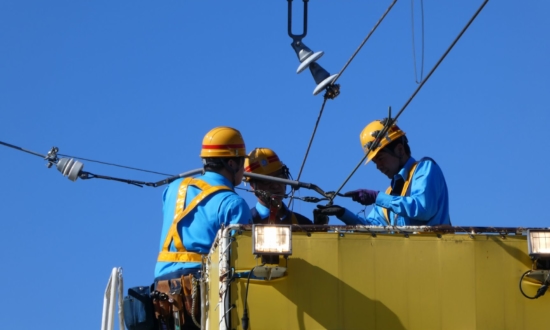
left=328, top=0, right=489, bottom=205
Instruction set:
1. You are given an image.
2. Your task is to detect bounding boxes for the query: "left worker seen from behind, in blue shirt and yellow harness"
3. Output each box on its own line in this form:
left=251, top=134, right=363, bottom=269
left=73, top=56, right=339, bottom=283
left=155, top=127, right=252, bottom=329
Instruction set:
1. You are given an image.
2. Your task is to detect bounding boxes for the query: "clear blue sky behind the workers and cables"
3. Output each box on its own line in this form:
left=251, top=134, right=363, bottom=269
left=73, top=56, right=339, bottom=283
left=0, top=0, right=550, bottom=329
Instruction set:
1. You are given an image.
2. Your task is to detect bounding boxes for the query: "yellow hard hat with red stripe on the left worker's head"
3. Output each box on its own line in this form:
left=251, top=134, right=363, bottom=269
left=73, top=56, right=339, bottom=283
left=201, top=126, right=246, bottom=158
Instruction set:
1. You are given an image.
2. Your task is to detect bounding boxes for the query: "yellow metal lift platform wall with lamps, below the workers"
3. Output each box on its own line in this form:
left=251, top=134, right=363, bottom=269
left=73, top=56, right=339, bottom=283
left=102, top=225, right=550, bottom=330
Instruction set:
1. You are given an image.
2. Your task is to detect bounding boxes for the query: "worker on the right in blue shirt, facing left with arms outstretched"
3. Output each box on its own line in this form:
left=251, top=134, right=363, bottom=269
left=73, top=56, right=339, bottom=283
left=318, top=119, right=451, bottom=226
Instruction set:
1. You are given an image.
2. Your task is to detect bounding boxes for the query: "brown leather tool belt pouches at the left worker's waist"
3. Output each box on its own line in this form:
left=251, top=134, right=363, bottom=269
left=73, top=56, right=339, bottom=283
left=151, top=274, right=200, bottom=329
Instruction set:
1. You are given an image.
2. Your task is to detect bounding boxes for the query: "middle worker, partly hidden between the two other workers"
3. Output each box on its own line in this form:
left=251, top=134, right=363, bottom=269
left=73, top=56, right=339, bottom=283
left=244, top=148, right=313, bottom=225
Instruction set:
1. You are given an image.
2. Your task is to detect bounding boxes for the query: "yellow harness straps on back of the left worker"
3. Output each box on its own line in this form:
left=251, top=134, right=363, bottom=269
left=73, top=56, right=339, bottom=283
left=157, top=178, right=232, bottom=262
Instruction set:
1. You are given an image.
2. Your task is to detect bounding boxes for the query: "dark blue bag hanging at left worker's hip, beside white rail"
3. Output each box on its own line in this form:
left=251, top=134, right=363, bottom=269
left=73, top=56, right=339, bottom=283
left=124, top=286, right=157, bottom=330
